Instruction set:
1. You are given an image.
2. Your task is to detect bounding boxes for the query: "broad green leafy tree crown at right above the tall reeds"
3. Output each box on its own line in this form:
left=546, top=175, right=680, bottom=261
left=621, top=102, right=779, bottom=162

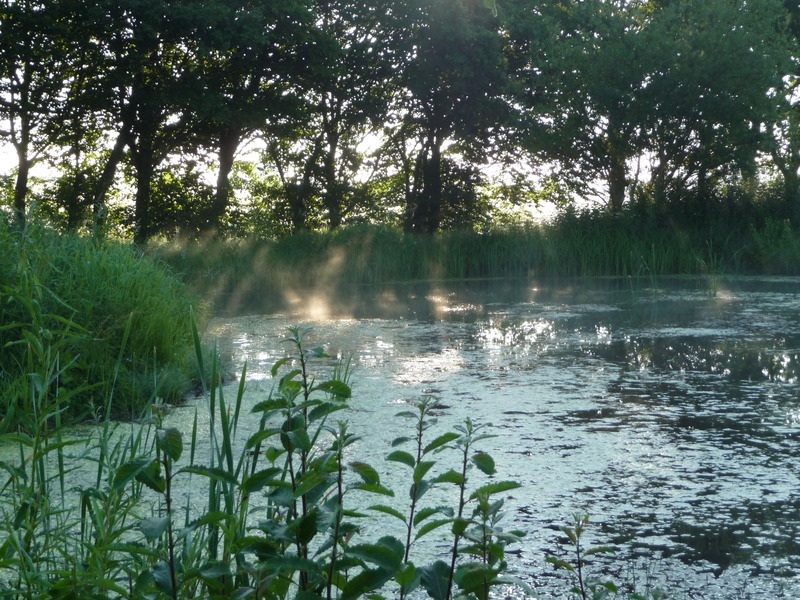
left=504, top=0, right=783, bottom=211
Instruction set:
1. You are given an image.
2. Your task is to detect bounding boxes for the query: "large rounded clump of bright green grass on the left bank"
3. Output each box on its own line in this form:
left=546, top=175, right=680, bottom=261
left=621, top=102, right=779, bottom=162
left=0, top=223, right=202, bottom=430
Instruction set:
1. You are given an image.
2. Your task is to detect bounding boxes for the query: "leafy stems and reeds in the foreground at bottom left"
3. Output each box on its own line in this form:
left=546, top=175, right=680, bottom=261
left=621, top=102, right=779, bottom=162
left=0, top=316, right=521, bottom=600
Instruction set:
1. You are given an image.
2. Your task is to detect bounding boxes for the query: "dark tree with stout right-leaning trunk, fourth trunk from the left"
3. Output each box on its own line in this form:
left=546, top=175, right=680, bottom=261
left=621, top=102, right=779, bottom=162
left=183, top=0, right=324, bottom=233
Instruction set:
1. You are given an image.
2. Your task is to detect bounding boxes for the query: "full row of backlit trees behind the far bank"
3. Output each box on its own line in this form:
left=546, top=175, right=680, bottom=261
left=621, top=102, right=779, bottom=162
left=0, top=0, right=800, bottom=240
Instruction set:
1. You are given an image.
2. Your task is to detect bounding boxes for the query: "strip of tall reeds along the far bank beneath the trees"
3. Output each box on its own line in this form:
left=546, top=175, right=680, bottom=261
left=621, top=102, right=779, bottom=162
left=148, top=210, right=800, bottom=305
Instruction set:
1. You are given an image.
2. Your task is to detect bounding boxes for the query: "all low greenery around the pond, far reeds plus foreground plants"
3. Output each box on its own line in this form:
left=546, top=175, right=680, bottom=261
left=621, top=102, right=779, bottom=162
left=0, top=205, right=800, bottom=600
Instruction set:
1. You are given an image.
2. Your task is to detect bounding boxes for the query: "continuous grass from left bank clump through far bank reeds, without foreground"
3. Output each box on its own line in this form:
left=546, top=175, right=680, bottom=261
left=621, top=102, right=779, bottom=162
left=0, top=201, right=800, bottom=422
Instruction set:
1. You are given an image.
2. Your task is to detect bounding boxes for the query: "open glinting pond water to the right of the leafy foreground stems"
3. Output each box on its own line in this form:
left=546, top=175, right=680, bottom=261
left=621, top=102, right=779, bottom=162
left=202, top=278, right=800, bottom=600
